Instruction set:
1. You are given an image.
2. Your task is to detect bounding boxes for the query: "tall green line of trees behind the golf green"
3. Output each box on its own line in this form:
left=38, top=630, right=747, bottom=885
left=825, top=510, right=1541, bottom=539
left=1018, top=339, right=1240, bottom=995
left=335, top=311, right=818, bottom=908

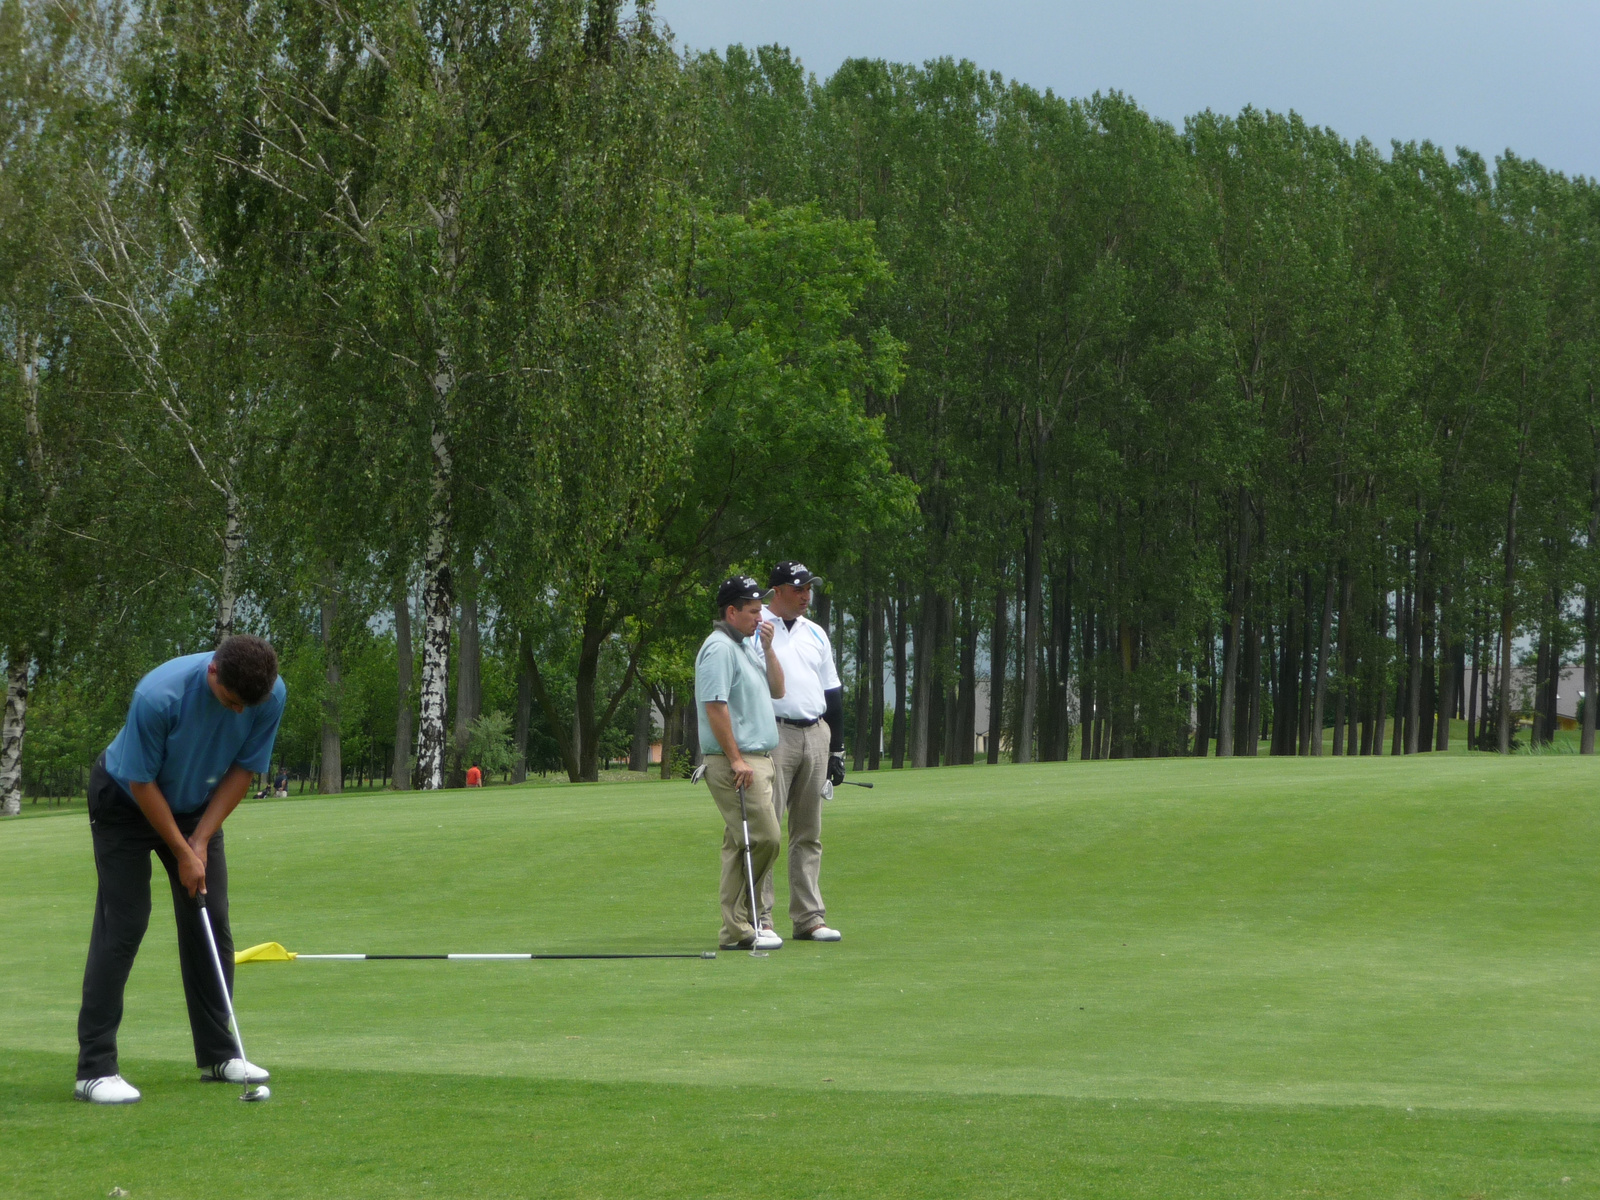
left=0, top=0, right=1600, bottom=806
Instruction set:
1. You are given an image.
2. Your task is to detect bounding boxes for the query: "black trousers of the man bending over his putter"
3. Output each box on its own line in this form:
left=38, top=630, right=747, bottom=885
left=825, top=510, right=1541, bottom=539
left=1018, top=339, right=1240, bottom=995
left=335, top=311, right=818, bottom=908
left=78, top=762, right=238, bottom=1078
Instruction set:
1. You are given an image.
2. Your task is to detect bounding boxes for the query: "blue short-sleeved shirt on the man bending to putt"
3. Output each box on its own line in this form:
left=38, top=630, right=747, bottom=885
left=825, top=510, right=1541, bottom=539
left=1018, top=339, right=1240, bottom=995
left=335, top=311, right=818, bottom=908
left=106, top=651, right=288, bottom=813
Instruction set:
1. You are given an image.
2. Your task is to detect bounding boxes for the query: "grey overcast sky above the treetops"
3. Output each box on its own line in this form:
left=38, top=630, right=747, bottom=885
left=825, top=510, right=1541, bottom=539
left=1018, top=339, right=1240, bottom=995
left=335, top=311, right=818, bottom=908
left=656, top=0, right=1600, bottom=176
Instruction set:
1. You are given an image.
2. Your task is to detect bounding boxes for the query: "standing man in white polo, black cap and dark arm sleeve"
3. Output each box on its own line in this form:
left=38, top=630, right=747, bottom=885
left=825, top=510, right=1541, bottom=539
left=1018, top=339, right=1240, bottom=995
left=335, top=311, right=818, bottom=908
left=762, top=562, right=845, bottom=942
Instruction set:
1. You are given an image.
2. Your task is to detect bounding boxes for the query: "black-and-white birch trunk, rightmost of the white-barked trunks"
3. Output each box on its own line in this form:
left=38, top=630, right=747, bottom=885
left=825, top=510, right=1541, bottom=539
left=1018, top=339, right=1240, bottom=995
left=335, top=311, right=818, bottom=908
left=416, top=409, right=454, bottom=792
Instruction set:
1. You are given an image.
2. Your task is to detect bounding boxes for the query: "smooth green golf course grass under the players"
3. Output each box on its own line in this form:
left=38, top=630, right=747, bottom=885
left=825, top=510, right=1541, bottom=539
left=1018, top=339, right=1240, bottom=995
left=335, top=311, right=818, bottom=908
left=9, top=755, right=1600, bottom=1198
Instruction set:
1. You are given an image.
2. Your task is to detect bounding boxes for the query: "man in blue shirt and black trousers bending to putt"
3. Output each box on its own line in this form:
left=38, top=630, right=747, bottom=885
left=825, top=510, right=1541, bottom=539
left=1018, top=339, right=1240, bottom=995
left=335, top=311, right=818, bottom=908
left=72, top=637, right=286, bottom=1104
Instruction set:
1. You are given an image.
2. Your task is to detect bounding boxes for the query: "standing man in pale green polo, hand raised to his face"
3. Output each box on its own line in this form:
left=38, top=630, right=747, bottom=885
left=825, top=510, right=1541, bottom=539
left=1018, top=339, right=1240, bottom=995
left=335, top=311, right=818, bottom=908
left=694, top=574, right=784, bottom=950
